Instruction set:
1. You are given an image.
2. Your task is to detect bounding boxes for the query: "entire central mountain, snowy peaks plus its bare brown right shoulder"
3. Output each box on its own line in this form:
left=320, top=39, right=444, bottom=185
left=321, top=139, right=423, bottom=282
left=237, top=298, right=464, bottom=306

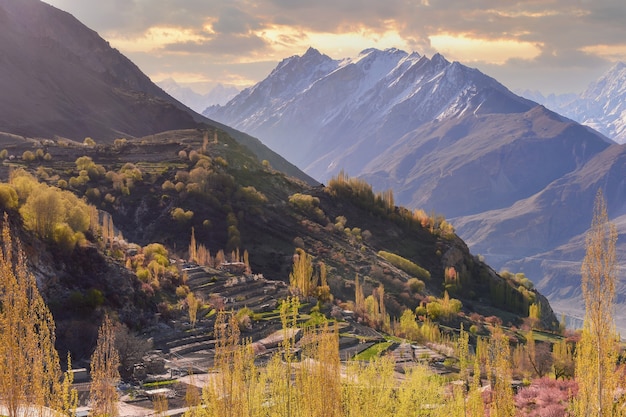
left=204, top=48, right=610, bottom=213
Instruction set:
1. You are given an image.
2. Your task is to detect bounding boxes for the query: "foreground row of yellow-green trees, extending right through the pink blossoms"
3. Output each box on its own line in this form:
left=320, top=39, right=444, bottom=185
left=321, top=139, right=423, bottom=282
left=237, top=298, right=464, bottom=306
left=185, top=298, right=590, bottom=417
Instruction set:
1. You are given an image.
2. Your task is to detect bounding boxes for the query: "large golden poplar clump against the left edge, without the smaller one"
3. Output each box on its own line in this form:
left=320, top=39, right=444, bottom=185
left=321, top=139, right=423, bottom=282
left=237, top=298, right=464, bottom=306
left=0, top=214, right=71, bottom=417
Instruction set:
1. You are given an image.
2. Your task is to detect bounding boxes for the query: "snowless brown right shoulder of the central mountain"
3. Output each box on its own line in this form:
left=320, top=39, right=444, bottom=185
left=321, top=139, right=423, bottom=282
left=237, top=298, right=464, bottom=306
left=361, top=107, right=608, bottom=217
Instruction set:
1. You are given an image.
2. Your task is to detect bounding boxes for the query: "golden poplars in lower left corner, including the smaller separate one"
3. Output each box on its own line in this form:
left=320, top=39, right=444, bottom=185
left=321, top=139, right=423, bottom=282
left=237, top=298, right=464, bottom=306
left=0, top=214, right=120, bottom=417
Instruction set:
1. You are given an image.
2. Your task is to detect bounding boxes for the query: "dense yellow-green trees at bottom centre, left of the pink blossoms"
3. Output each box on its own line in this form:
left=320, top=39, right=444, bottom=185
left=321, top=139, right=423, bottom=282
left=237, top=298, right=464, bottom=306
left=185, top=299, right=464, bottom=417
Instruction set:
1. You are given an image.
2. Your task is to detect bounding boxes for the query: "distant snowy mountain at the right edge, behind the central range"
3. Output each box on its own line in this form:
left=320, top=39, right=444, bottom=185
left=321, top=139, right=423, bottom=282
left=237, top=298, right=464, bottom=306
left=522, top=62, right=626, bottom=143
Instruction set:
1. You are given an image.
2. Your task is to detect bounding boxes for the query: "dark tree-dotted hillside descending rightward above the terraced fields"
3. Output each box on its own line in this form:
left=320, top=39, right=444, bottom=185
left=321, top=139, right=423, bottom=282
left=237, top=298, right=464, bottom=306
left=0, top=129, right=557, bottom=356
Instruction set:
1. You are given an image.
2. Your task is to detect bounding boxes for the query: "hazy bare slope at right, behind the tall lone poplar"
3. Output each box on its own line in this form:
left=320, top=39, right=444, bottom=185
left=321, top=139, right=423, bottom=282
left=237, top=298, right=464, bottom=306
left=454, top=141, right=626, bottom=328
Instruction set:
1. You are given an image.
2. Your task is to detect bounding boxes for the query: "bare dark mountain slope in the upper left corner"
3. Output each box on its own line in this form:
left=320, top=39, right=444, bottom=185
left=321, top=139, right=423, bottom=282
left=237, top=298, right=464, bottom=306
left=0, top=0, right=316, bottom=184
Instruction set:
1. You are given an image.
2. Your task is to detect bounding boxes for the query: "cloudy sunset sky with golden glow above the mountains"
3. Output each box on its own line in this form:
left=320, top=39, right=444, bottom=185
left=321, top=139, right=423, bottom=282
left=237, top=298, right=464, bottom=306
left=41, top=0, right=626, bottom=94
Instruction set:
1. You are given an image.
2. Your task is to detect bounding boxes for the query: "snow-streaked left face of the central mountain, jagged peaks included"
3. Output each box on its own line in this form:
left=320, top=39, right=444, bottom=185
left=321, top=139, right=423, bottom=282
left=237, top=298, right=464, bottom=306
left=204, top=48, right=533, bottom=181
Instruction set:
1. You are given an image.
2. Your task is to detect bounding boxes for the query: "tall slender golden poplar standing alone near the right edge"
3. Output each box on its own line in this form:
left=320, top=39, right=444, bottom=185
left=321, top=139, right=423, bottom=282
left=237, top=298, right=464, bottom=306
left=575, top=190, right=618, bottom=417
